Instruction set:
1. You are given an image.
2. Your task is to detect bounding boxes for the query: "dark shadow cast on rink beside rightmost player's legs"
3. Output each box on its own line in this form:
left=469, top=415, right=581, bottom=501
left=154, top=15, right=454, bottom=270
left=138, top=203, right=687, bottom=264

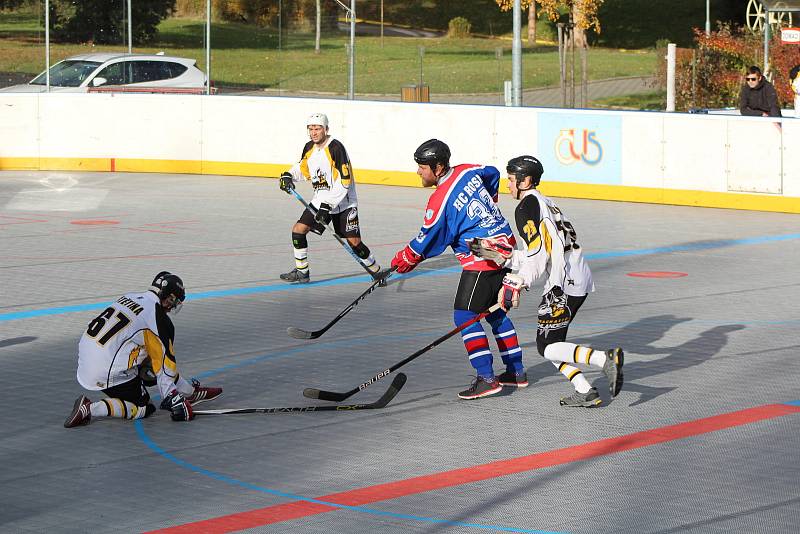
left=523, top=315, right=745, bottom=406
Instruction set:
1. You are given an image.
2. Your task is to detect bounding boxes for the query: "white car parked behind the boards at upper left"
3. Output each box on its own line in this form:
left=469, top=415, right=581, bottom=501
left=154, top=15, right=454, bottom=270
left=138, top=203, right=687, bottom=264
left=0, top=53, right=206, bottom=93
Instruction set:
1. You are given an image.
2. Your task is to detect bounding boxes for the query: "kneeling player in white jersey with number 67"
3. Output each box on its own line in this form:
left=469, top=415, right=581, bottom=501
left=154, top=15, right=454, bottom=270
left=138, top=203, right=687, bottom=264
left=64, top=271, right=222, bottom=428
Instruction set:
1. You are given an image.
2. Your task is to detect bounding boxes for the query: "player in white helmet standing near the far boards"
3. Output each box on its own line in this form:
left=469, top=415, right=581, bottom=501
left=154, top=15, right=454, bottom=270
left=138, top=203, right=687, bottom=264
left=280, top=113, right=381, bottom=284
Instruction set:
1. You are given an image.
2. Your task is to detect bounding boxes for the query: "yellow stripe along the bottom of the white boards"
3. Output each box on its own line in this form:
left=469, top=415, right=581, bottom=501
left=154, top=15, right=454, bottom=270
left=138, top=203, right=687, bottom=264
left=0, top=157, right=800, bottom=213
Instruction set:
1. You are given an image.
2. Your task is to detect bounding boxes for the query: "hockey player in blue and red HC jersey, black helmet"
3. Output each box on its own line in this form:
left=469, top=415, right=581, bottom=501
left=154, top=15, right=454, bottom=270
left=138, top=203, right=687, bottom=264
left=392, top=139, right=528, bottom=399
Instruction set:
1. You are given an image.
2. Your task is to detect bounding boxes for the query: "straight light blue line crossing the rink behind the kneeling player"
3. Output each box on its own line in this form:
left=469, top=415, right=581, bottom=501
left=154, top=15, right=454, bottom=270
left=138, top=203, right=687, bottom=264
left=0, top=230, right=800, bottom=322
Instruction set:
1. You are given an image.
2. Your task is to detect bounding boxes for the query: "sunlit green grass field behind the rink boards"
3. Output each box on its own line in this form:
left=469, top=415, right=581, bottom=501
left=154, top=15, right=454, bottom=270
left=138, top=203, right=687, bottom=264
left=0, top=12, right=657, bottom=94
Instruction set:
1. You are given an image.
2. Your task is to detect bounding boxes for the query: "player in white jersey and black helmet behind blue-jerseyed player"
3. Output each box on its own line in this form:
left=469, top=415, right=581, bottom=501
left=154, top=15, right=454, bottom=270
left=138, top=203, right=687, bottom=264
left=473, top=156, right=624, bottom=407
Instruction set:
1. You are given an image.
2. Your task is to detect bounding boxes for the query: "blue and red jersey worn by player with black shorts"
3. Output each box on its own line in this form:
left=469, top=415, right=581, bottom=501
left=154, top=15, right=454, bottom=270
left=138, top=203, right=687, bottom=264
left=408, top=164, right=515, bottom=271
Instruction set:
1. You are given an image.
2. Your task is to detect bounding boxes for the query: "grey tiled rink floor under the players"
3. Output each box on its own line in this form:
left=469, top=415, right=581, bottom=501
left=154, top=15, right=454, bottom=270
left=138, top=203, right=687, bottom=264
left=0, top=172, right=800, bottom=533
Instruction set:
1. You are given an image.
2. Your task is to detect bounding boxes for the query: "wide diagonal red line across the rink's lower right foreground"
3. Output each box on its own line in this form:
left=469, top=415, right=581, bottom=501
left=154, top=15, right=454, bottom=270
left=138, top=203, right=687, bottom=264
left=145, top=404, right=800, bottom=533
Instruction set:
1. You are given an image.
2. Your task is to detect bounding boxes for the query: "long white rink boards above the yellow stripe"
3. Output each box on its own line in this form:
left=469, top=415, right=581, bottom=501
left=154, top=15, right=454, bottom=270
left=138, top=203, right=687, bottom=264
left=0, top=93, right=800, bottom=201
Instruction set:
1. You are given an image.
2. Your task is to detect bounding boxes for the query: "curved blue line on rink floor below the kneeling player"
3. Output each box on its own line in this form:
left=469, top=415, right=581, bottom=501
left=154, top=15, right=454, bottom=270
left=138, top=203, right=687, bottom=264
left=134, top=419, right=567, bottom=534
